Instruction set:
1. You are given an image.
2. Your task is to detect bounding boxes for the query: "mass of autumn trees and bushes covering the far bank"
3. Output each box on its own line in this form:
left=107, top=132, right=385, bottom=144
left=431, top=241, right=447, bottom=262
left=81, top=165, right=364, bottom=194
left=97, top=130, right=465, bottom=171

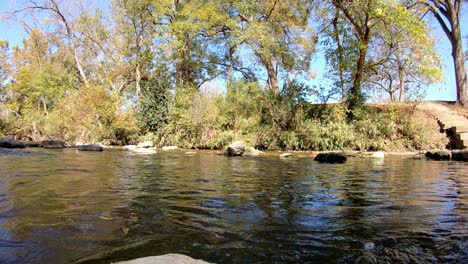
left=0, top=0, right=452, bottom=149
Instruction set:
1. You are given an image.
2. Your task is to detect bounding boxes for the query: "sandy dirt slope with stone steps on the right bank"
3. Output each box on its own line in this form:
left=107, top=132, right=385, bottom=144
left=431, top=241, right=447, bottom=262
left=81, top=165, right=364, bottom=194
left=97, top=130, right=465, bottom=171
left=417, top=102, right=468, bottom=149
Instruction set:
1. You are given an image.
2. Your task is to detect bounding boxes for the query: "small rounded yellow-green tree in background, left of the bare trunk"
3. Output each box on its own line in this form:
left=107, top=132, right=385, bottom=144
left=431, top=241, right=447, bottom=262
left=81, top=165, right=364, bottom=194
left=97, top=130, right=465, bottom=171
left=367, top=1, right=443, bottom=101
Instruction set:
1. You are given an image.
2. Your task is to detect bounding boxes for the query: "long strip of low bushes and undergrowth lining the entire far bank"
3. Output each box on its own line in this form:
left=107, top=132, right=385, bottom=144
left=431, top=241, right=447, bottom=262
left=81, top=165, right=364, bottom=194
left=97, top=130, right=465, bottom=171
left=2, top=82, right=447, bottom=151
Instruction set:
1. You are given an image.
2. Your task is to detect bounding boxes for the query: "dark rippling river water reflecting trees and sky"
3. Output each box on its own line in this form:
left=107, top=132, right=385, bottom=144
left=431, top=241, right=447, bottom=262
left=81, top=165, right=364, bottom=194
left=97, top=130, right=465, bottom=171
left=0, top=149, right=468, bottom=263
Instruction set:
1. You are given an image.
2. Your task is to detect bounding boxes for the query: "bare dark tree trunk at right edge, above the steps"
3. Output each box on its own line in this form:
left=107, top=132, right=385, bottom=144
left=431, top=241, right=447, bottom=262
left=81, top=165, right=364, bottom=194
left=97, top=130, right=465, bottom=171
left=416, top=0, right=468, bottom=107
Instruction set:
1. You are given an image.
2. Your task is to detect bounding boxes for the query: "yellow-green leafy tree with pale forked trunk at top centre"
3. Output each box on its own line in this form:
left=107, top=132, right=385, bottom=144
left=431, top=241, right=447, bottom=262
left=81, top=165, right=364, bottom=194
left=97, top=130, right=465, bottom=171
left=227, top=0, right=316, bottom=95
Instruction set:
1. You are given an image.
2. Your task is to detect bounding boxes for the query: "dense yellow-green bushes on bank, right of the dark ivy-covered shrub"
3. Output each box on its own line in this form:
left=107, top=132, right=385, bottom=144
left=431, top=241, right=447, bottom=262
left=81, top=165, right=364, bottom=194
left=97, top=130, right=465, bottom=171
left=153, top=82, right=438, bottom=150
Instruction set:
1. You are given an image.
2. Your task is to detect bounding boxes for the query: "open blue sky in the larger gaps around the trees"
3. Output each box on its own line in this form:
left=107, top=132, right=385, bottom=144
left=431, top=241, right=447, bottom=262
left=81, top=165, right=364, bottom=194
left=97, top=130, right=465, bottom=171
left=0, top=0, right=468, bottom=100
